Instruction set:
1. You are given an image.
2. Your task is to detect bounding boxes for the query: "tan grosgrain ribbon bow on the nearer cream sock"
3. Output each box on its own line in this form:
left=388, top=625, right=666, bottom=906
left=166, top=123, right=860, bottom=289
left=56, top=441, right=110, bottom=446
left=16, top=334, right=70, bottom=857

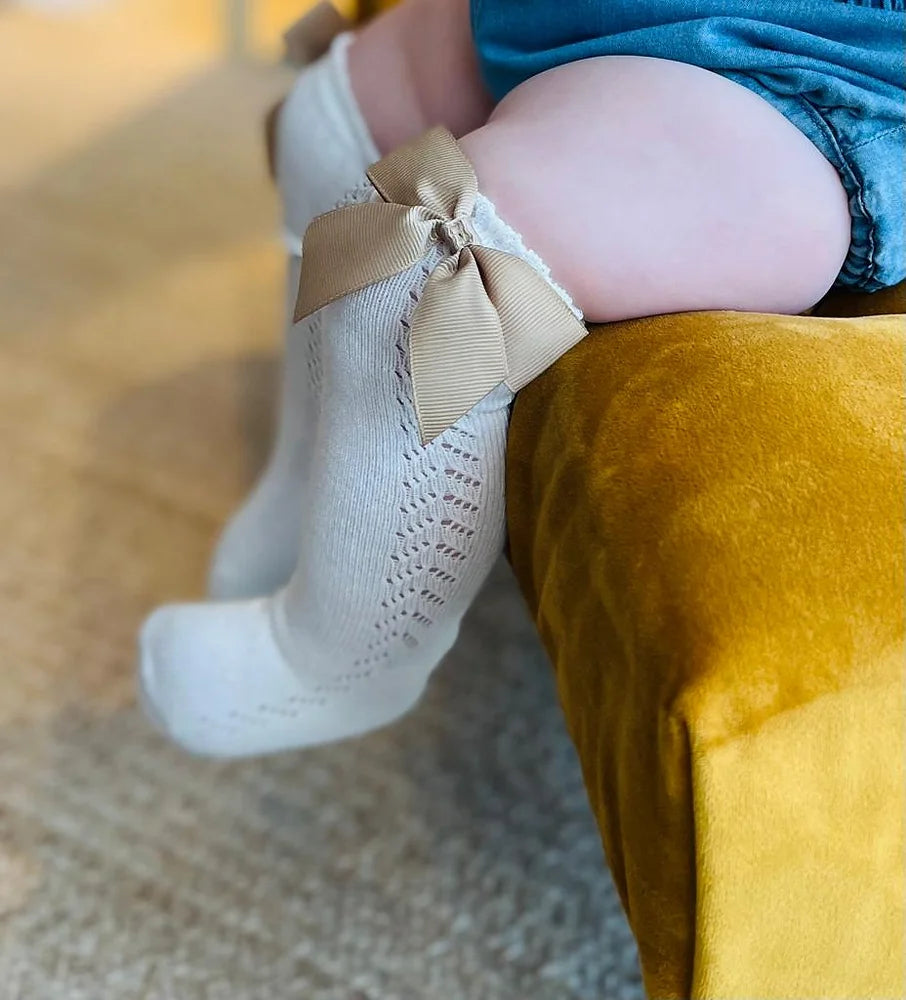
left=295, top=128, right=586, bottom=443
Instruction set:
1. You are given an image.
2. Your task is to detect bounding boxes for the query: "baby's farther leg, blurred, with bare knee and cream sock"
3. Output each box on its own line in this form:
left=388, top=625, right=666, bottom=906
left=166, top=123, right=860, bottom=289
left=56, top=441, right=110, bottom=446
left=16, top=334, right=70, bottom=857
left=208, top=0, right=490, bottom=600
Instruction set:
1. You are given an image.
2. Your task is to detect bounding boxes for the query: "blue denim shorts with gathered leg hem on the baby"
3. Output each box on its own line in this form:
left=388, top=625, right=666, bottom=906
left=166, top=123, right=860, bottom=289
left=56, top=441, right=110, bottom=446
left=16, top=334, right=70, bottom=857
left=472, top=0, right=906, bottom=291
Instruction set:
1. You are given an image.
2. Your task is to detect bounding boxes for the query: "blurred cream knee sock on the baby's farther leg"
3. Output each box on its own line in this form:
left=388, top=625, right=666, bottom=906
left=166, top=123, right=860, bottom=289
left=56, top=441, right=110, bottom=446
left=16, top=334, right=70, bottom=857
left=208, top=35, right=379, bottom=600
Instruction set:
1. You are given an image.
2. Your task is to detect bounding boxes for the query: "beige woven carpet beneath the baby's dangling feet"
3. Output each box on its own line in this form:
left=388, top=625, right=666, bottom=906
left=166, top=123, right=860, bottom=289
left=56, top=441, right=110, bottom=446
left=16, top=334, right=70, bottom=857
left=0, top=0, right=641, bottom=1000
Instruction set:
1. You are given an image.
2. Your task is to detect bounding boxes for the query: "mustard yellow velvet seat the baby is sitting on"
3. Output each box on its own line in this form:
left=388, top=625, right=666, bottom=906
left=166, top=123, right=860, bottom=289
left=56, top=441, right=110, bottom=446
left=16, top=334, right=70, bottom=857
left=508, top=290, right=906, bottom=1000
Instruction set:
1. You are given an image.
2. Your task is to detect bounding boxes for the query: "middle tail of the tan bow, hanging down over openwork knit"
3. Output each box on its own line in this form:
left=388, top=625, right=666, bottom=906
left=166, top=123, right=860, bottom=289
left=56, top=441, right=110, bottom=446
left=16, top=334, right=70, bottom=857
left=409, top=249, right=507, bottom=444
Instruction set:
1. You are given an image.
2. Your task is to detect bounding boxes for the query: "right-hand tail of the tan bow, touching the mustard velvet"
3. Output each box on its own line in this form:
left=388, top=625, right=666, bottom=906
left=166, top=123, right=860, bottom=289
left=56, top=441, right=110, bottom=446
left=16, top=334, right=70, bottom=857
left=474, top=246, right=588, bottom=392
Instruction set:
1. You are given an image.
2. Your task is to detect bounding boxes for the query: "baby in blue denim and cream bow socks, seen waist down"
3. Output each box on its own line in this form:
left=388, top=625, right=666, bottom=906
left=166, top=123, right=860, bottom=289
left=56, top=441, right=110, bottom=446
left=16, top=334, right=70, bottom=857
left=141, top=0, right=906, bottom=757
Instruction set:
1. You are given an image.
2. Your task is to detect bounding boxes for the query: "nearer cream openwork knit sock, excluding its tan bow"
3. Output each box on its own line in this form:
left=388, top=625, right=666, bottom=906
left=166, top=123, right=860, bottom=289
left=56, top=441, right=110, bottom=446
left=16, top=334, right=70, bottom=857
left=141, top=184, right=580, bottom=756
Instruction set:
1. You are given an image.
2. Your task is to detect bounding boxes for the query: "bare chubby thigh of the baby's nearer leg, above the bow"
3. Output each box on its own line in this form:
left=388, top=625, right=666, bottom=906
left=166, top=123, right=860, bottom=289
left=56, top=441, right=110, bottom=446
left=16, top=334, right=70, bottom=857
left=462, top=56, right=850, bottom=322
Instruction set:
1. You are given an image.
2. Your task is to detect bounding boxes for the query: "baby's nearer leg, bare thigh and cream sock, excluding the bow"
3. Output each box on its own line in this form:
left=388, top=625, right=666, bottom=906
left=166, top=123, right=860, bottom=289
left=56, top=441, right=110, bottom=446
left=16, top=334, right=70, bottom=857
left=142, top=56, right=846, bottom=756
